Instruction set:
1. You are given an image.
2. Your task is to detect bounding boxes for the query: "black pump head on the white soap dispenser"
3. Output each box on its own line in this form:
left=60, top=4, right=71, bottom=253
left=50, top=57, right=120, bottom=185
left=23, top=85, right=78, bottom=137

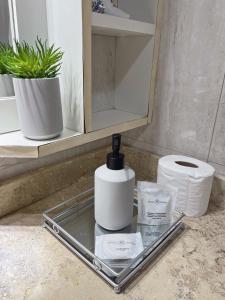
left=106, top=133, right=124, bottom=170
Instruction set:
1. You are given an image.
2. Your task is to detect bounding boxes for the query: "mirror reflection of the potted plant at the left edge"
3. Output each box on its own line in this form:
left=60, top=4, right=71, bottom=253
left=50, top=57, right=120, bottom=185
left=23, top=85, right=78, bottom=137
left=0, top=42, right=14, bottom=97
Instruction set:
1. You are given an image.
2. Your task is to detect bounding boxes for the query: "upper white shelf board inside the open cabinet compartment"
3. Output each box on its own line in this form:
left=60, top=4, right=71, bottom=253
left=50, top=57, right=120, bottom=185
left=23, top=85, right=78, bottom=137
left=92, top=13, right=155, bottom=36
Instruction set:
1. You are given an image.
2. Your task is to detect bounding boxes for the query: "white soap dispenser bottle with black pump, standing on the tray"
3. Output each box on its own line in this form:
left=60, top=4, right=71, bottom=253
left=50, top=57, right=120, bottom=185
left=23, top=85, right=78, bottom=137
left=95, top=134, right=135, bottom=230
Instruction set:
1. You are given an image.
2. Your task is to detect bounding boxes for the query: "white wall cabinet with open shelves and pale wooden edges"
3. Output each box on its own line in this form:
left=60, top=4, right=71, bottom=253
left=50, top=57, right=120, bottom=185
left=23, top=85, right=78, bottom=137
left=0, top=0, right=159, bottom=158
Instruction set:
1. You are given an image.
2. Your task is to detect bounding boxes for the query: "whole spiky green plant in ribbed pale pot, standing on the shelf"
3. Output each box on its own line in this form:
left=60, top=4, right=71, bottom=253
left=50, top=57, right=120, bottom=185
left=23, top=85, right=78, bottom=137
left=7, top=39, right=63, bottom=140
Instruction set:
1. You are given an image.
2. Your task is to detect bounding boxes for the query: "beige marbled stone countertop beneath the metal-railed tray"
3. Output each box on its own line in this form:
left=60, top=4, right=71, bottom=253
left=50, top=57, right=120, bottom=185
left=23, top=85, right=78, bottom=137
left=0, top=177, right=225, bottom=300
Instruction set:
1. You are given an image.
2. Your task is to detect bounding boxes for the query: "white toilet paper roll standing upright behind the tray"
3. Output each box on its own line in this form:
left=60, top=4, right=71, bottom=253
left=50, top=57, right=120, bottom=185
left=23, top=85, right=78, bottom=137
left=157, top=155, right=215, bottom=217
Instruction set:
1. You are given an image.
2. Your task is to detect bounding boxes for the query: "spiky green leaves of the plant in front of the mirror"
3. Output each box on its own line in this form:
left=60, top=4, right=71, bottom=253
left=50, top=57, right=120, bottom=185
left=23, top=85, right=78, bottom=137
left=6, top=38, right=63, bottom=79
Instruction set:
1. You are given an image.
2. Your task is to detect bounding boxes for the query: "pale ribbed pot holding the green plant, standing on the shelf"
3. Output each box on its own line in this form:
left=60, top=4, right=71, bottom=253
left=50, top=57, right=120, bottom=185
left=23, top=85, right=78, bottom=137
left=13, top=78, right=63, bottom=140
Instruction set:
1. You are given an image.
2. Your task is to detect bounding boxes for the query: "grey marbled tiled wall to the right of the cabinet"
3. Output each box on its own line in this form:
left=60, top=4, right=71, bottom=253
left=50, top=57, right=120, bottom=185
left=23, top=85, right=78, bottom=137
left=125, top=0, right=225, bottom=175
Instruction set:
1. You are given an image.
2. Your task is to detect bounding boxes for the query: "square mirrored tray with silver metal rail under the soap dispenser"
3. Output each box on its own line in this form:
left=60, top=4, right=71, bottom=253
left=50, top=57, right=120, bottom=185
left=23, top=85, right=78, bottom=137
left=43, top=189, right=184, bottom=293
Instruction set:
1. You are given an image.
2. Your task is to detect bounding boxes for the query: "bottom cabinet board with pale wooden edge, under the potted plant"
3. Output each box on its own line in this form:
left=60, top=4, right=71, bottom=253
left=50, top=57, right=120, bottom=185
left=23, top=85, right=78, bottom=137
left=0, top=118, right=148, bottom=158
